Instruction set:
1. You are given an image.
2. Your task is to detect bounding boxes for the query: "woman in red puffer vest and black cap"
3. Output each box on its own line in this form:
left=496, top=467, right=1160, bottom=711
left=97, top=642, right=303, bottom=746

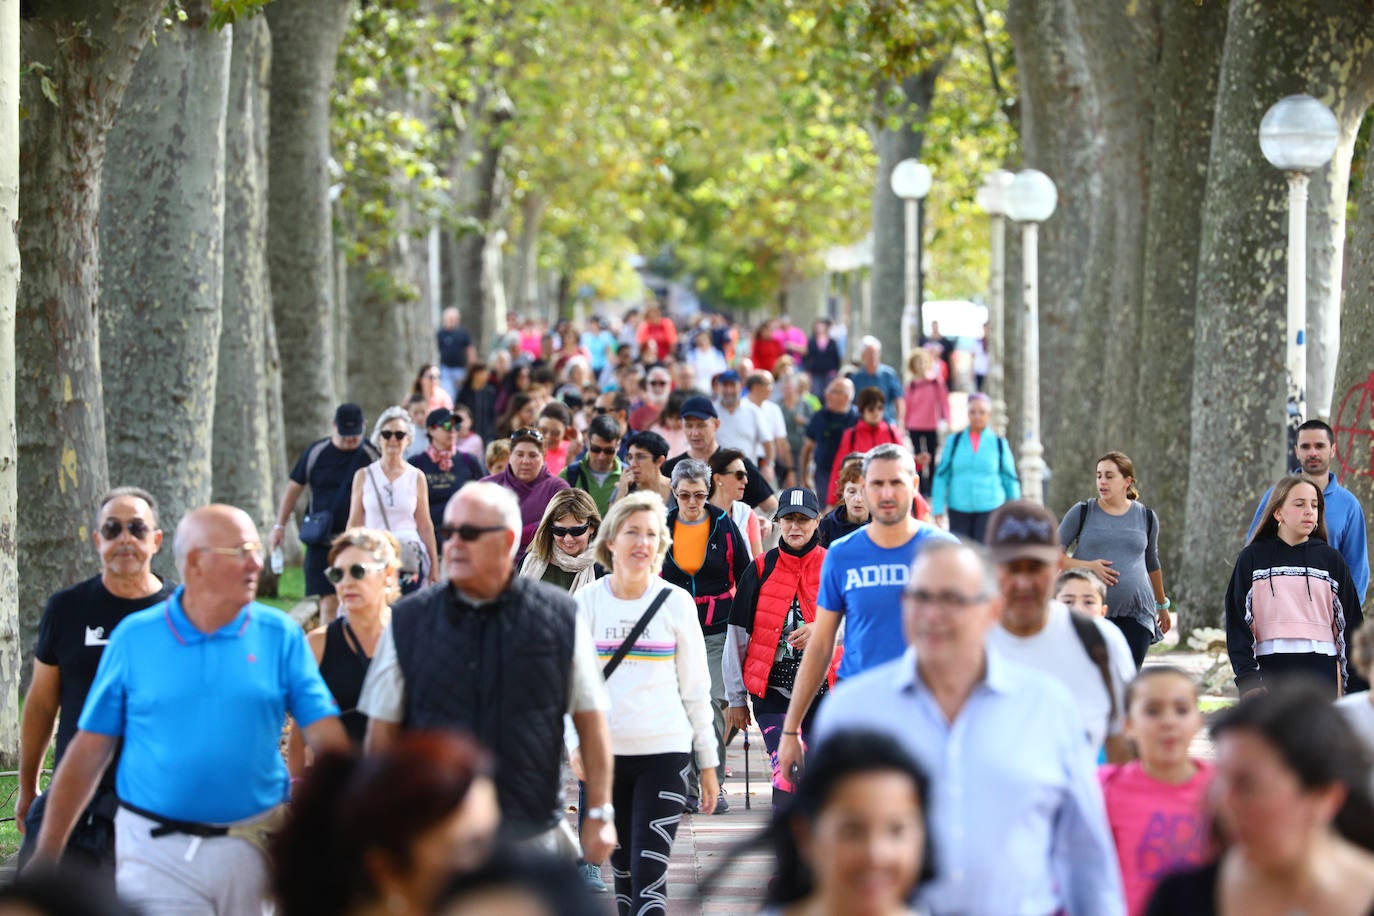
left=721, top=486, right=840, bottom=809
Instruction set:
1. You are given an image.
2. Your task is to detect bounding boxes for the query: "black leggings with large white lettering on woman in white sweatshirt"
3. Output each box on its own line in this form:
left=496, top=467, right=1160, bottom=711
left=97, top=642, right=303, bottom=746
left=610, top=754, right=691, bottom=916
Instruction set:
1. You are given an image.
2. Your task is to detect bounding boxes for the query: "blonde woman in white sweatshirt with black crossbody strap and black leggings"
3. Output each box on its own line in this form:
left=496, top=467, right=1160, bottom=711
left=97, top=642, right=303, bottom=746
left=573, top=492, right=720, bottom=916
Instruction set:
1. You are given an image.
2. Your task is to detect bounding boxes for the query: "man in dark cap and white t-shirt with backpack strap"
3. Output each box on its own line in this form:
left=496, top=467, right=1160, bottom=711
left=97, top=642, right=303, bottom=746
left=988, top=500, right=1135, bottom=764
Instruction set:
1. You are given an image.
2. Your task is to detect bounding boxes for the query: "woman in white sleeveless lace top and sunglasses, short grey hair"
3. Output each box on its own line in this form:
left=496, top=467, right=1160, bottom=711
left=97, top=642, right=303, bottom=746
left=348, top=407, right=438, bottom=595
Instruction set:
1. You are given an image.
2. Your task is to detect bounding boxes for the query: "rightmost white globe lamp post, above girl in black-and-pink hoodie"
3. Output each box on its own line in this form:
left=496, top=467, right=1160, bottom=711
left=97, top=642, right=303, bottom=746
left=1260, top=95, right=1340, bottom=467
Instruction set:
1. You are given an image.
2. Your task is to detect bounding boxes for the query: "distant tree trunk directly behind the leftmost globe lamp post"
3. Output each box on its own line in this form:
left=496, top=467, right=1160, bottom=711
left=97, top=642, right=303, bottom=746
left=868, top=62, right=944, bottom=368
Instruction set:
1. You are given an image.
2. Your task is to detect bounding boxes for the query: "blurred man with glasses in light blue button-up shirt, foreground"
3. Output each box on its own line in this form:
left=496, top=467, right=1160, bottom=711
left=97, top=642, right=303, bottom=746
left=815, top=541, right=1125, bottom=916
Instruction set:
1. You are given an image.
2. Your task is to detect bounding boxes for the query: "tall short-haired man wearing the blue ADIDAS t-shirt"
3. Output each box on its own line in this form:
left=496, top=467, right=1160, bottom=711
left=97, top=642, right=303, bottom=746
left=778, top=445, right=954, bottom=773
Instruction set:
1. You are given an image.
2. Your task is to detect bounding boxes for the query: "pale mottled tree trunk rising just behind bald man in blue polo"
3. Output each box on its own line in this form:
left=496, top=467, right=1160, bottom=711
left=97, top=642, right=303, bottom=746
left=100, top=0, right=231, bottom=578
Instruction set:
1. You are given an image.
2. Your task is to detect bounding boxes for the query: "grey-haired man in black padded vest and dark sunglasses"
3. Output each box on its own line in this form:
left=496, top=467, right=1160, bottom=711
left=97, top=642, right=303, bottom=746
left=359, top=483, right=616, bottom=864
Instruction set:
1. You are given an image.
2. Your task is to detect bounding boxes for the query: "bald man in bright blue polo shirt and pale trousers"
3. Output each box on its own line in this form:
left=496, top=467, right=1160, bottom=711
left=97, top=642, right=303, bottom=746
left=33, top=505, right=349, bottom=916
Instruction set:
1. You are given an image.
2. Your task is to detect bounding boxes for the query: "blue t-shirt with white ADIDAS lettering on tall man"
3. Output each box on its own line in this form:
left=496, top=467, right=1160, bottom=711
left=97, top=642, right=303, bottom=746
left=816, top=522, right=954, bottom=677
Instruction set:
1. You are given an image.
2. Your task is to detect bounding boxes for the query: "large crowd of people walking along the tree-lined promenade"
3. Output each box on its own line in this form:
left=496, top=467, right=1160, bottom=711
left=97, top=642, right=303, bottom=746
left=3, top=304, right=1374, bottom=916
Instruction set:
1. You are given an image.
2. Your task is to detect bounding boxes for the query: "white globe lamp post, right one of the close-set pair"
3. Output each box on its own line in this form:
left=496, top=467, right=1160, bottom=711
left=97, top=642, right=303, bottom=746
left=1006, top=169, right=1059, bottom=503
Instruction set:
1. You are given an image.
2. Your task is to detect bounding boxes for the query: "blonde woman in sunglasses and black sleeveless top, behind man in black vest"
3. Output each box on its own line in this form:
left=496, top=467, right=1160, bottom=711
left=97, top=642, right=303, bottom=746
left=286, top=527, right=401, bottom=779
